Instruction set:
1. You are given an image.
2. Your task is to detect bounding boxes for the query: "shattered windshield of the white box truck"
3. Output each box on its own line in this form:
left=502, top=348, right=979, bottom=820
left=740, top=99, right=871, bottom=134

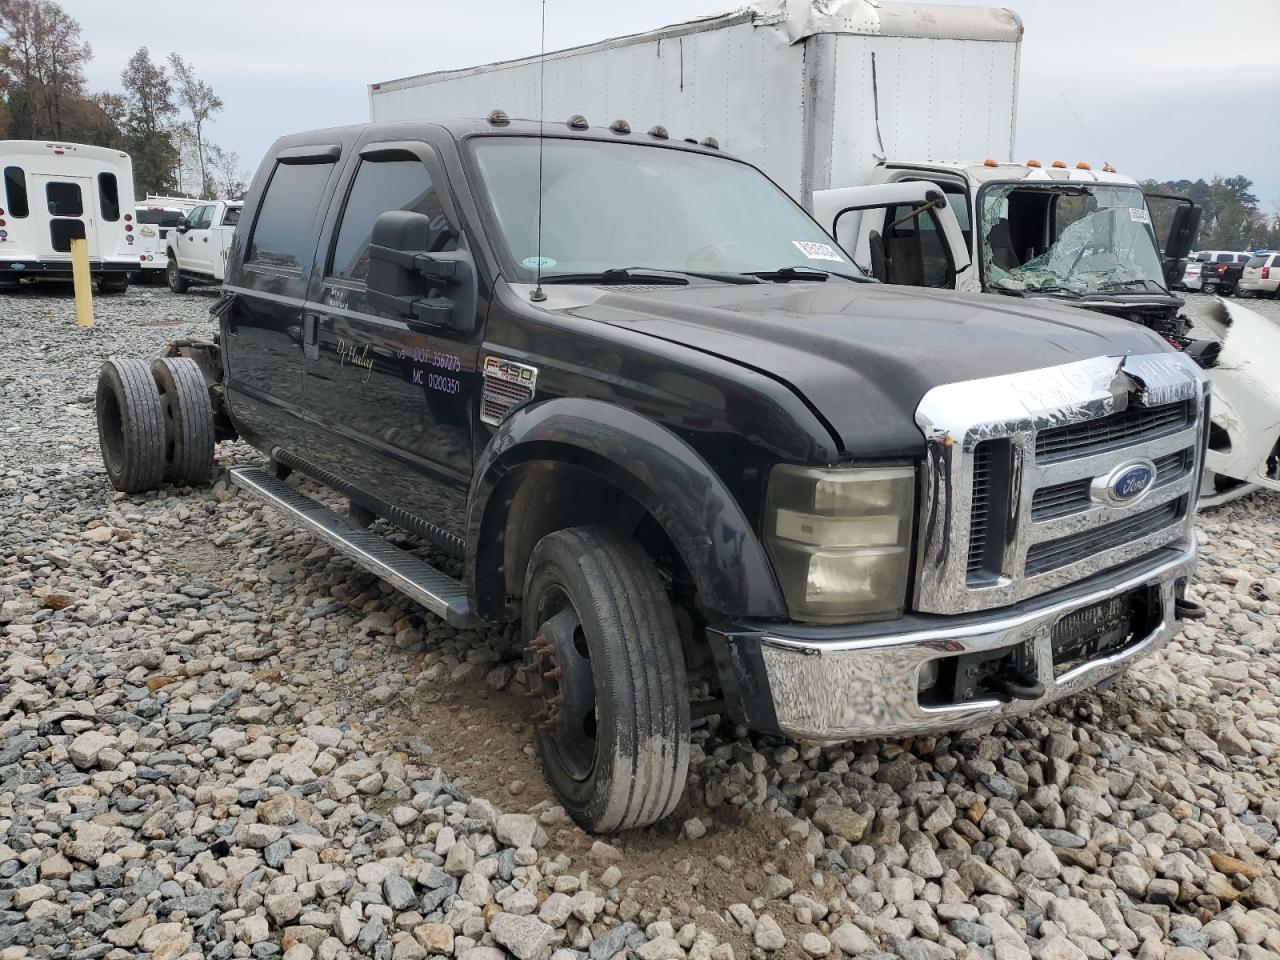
left=979, top=183, right=1165, bottom=294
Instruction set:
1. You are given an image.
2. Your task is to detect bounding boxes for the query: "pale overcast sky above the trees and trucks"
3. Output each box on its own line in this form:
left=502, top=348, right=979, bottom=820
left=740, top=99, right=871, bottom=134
left=61, top=0, right=1280, bottom=211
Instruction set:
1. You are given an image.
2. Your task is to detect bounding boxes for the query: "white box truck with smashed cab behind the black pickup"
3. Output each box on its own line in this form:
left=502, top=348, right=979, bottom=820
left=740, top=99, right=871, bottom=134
left=369, top=0, right=1280, bottom=512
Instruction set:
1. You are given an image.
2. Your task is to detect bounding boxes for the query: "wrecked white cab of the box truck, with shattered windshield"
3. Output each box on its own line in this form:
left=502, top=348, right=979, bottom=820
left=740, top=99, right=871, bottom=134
left=812, top=160, right=1280, bottom=506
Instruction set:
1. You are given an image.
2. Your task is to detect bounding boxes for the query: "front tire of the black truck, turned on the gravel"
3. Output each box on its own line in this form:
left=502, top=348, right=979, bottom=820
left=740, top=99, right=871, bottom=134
left=522, top=527, right=690, bottom=833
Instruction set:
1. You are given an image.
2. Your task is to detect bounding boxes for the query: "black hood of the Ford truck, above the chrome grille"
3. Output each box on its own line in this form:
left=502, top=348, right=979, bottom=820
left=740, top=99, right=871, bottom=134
left=527, top=279, right=1170, bottom=457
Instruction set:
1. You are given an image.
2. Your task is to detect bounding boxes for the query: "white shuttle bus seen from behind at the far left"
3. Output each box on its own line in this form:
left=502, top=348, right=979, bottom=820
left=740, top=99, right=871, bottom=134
left=0, top=140, right=141, bottom=293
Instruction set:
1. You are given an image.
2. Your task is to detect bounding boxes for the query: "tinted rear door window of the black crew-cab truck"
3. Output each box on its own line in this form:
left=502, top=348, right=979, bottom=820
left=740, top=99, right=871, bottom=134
left=246, top=163, right=333, bottom=271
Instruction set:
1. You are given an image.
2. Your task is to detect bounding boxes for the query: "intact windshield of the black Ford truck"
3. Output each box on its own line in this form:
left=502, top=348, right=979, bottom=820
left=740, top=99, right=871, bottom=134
left=472, top=137, right=859, bottom=283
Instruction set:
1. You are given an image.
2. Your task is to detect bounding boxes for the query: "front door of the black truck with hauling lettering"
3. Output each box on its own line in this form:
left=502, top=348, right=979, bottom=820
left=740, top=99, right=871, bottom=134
left=303, top=141, right=480, bottom=536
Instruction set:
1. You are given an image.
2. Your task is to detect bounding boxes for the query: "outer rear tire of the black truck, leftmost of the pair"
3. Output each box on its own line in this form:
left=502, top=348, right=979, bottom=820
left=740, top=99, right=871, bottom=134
left=96, top=360, right=165, bottom=493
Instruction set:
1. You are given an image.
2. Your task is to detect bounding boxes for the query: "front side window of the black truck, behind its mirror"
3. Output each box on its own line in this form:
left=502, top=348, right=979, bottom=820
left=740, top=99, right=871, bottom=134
left=328, top=157, right=457, bottom=280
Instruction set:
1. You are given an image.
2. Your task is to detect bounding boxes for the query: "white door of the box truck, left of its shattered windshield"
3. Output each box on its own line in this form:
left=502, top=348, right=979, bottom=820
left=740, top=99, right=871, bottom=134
left=813, top=180, right=969, bottom=288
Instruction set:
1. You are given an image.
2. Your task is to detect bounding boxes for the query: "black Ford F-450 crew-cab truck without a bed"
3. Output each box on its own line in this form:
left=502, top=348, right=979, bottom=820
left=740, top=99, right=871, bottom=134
left=99, top=114, right=1208, bottom=832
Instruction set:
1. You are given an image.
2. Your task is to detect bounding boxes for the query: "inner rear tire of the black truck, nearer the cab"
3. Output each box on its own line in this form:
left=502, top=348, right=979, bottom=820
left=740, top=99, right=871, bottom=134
left=151, top=357, right=214, bottom=486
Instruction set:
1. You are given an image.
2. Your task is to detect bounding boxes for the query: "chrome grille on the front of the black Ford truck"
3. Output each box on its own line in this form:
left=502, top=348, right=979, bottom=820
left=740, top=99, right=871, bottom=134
left=913, top=353, right=1208, bottom=613
